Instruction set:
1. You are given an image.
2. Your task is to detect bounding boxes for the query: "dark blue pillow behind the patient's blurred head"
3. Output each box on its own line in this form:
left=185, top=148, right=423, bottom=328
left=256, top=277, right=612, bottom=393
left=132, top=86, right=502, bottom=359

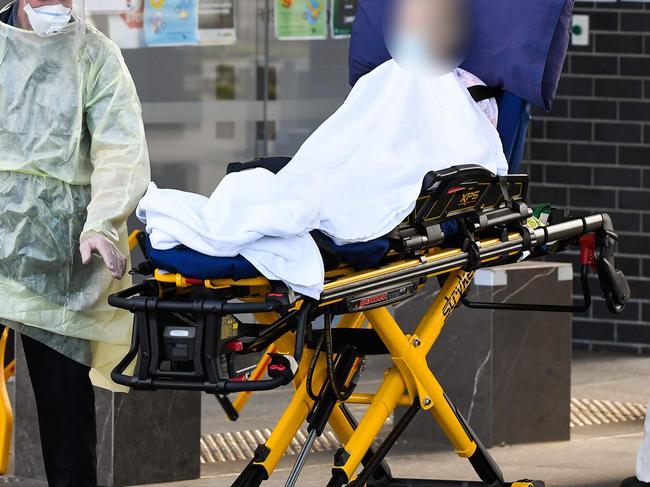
left=350, top=0, right=575, bottom=110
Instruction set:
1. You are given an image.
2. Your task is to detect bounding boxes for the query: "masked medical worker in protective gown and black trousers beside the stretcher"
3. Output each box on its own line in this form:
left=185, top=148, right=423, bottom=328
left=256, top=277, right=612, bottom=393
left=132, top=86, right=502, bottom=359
left=0, top=0, right=150, bottom=487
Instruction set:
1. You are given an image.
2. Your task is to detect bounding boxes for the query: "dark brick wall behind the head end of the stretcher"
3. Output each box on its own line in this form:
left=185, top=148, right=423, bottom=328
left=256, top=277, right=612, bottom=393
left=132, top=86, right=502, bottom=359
left=526, top=2, right=650, bottom=352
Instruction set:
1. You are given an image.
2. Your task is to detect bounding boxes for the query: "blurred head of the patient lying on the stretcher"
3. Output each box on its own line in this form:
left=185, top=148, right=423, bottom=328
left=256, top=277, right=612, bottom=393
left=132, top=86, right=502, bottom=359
left=386, top=0, right=470, bottom=76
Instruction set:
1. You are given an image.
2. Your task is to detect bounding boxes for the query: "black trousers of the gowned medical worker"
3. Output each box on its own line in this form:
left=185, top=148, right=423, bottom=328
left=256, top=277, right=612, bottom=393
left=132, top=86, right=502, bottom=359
left=21, top=335, right=97, bottom=487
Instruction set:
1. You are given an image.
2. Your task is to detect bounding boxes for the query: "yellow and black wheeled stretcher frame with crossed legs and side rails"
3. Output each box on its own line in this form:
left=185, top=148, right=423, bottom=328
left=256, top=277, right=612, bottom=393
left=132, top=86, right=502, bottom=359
left=109, top=166, right=630, bottom=487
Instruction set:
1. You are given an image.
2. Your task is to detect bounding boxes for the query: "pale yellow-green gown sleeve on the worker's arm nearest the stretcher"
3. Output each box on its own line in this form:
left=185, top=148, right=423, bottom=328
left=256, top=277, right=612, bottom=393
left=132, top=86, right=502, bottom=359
left=80, top=41, right=151, bottom=243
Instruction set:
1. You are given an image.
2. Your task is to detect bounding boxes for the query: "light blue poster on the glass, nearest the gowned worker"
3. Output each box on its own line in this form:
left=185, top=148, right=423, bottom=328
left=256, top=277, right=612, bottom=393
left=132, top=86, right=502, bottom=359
left=144, top=0, right=199, bottom=46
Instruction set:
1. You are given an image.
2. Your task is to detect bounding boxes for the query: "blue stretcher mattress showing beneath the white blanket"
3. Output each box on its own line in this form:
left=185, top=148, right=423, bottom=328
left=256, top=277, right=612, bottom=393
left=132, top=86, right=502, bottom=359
left=146, top=234, right=390, bottom=280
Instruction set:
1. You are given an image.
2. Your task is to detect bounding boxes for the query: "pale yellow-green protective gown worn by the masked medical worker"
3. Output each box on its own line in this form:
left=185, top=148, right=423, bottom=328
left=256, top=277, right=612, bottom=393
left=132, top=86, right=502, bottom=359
left=0, top=9, right=150, bottom=390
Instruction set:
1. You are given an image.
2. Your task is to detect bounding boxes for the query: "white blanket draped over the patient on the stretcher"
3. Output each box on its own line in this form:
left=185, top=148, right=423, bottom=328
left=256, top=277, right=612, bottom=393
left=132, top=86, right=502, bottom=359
left=137, top=61, right=507, bottom=297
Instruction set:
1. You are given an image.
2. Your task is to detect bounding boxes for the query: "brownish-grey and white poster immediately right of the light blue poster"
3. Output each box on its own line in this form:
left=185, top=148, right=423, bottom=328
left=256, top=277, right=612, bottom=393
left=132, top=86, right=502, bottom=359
left=199, top=0, right=237, bottom=45
